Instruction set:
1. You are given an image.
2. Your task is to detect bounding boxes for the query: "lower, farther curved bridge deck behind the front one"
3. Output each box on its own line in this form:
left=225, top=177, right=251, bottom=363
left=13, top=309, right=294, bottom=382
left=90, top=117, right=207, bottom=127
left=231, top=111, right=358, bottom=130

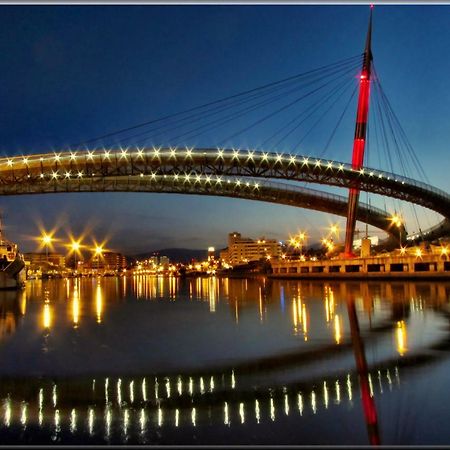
left=0, top=175, right=400, bottom=242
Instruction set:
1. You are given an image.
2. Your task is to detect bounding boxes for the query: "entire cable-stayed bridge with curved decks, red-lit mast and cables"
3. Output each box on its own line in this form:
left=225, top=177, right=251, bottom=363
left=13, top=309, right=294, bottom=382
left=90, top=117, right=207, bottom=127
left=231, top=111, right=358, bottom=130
left=0, top=10, right=450, bottom=251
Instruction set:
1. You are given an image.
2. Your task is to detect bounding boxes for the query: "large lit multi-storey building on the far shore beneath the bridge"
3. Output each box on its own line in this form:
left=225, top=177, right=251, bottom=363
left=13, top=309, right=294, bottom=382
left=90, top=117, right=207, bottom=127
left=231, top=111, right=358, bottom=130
left=220, top=232, right=281, bottom=266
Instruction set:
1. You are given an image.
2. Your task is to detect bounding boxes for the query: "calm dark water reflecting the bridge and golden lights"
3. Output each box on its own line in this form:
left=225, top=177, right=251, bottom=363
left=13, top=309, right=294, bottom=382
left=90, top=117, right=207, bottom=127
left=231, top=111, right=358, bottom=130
left=0, top=276, right=450, bottom=445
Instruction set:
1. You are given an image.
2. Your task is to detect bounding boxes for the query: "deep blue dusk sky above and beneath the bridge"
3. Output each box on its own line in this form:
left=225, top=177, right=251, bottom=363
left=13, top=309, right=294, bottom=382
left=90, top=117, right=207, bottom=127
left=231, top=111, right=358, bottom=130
left=0, top=5, right=450, bottom=254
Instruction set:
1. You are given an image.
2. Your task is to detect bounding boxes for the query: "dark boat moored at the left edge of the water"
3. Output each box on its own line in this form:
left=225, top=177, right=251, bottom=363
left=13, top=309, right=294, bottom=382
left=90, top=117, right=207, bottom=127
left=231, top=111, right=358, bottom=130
left=0, top=217, right=26, bottom=289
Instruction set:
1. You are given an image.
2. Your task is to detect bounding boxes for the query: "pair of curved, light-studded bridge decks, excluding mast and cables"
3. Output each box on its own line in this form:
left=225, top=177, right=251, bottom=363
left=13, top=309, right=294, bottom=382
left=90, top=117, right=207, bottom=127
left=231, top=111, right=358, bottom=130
left=0, top=147, right=450, bottom=244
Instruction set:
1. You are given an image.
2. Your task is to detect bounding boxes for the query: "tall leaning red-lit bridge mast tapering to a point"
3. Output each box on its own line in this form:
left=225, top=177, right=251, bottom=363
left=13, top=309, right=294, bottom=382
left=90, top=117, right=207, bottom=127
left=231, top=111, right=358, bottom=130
left=344, top=5, right=373, bottom=257
